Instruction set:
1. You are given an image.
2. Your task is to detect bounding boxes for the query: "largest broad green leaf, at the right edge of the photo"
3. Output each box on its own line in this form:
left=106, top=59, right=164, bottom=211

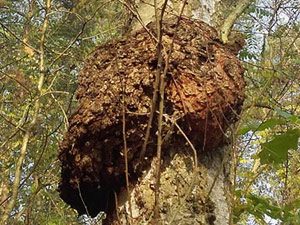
left=258, top=129, right=300, bottom=164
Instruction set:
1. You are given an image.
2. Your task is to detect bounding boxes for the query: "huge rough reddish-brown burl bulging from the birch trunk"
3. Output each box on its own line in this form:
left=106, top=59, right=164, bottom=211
left=59, top=18, right=245, bottom=221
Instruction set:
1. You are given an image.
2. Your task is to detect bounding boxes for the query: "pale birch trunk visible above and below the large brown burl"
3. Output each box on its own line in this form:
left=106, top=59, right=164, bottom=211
left=109, top=0, right=246, bottom=225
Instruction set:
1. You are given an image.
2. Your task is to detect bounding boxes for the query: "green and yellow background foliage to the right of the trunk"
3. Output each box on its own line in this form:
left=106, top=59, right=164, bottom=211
left=233, top=0, right=300, bottom=225
